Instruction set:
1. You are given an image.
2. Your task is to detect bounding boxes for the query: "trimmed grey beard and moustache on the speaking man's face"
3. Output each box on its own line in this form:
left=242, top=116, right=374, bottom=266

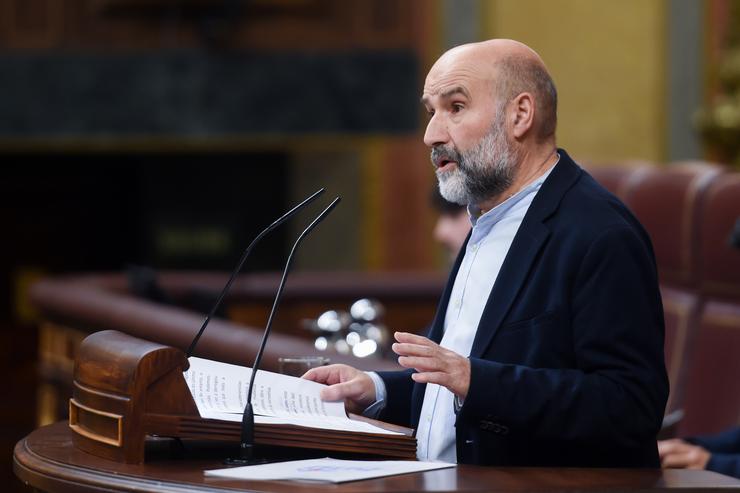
left=432, top=117, right=516, bottom=205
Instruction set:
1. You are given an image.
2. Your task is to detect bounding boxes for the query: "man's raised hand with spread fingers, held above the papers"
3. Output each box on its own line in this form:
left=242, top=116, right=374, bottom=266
left=393, top=332, right=470, bottom=399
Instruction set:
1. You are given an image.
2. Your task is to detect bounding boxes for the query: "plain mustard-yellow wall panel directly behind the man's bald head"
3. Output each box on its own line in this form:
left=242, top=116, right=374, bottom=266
left=482, top=0, right=667, bottom=161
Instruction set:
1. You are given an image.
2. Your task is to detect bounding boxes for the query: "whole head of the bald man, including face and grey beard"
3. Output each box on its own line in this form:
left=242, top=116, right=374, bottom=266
left=421, top=39, right=557, bottom=210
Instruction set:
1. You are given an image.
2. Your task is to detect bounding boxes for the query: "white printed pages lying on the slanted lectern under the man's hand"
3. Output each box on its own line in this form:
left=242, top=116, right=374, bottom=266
left=183, top=357, right=400, bottom=435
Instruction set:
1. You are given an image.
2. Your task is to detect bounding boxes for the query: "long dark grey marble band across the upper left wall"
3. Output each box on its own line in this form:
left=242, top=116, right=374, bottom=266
left=0, top=50, right=418, bottom=138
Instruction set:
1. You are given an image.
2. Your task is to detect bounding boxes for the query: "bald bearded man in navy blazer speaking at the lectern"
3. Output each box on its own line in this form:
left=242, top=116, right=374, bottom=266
left=304, top=40, right=668, bottom=467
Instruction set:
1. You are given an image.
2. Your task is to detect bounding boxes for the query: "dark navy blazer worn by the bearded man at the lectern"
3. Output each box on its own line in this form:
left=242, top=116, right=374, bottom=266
left=379, top=150, right=668, bottom=467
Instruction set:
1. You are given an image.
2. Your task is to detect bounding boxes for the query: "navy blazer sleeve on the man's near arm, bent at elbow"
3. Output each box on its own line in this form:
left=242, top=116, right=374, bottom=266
left=457, top=225, right=668, bottom=447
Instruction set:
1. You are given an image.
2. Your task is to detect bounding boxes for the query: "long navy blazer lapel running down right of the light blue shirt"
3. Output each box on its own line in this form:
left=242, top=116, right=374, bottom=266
left=468, top=149, right=582, bottom=358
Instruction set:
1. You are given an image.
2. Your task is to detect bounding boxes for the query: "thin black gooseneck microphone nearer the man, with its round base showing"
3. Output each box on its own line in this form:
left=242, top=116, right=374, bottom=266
left=224, top=197, right=341, bottom=466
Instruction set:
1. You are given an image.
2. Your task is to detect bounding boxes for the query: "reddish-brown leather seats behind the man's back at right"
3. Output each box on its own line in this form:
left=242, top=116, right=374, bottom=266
left=586, top=162, right=740, bottom=436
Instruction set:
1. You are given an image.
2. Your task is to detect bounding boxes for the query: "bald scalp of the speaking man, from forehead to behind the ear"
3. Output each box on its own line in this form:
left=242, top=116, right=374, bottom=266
left=430, top=39, right=558, bottom=141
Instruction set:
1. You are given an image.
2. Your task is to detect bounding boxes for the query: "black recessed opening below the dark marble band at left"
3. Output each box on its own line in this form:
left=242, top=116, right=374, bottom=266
left=0, top=153, right=287, bottom=274
